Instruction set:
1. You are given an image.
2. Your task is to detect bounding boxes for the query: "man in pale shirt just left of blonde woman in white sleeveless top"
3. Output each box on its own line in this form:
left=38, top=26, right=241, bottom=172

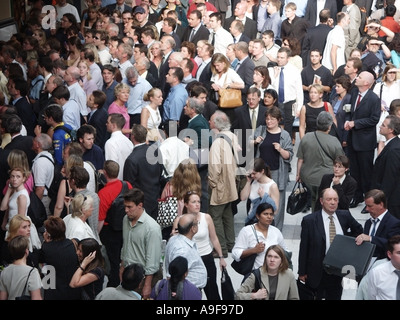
left=122, top=66, right=152, bottom=128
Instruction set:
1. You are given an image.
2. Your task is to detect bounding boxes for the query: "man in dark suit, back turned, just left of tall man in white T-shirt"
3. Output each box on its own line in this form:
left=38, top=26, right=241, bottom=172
left=301, top=9, right=336, bottom=66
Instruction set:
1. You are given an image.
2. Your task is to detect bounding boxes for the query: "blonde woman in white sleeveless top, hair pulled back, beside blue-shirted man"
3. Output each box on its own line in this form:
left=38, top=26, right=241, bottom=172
left=140, top=88, right=163, bottom=143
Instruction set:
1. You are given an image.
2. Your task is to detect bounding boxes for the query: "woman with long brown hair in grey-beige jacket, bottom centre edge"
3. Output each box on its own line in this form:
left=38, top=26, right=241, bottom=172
left=235, top=245, right=300, bottom=300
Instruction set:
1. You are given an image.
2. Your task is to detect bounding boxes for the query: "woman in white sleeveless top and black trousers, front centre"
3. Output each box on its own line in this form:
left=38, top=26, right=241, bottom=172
left=174, top=191, right=226, bottom=300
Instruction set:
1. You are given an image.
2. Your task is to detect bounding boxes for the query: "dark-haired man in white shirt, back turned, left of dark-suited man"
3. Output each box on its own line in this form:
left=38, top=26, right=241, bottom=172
left=104, top=113, right=133, bottom=180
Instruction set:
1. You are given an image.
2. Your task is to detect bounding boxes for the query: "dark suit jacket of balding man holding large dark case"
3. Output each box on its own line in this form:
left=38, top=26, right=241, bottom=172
left=298, top=210, right=363, bottom=289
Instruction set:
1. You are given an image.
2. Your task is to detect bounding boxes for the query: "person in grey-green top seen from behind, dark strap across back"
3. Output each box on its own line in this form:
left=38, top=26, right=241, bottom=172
left=296, top=111, right=344, bottom=212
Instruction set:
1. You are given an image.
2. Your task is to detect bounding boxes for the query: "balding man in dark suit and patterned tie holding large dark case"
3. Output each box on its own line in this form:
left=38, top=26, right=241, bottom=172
left=298, top=188, right=363, bottom=300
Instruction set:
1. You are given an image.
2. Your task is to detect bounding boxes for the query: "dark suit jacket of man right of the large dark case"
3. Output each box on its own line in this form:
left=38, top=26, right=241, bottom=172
left=364, top=211, right=400, bottom=259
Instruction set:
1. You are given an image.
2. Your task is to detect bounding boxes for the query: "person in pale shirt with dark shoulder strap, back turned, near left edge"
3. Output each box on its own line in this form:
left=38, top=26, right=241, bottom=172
left=32, top=133, right=54, bottom=216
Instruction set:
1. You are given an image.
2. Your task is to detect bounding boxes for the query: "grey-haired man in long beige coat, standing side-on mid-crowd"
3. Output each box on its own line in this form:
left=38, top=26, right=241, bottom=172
left=208, top=110, right=240, bottom=258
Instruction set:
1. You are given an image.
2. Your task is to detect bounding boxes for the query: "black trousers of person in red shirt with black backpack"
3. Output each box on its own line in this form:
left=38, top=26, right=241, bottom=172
left=100, top=225, right=122, bottom=287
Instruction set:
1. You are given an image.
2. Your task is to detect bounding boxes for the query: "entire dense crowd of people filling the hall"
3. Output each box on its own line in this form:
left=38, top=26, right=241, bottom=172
left=0, top=0, right=400, bottom=300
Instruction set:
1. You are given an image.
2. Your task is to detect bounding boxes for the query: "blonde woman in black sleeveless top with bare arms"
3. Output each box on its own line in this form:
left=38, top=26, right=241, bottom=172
left=299, top=83, right=337, bottom=139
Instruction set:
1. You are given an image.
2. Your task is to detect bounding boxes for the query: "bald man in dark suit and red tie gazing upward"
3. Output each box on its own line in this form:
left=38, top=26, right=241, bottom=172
left=344, top=71, right=381, bottom=211
